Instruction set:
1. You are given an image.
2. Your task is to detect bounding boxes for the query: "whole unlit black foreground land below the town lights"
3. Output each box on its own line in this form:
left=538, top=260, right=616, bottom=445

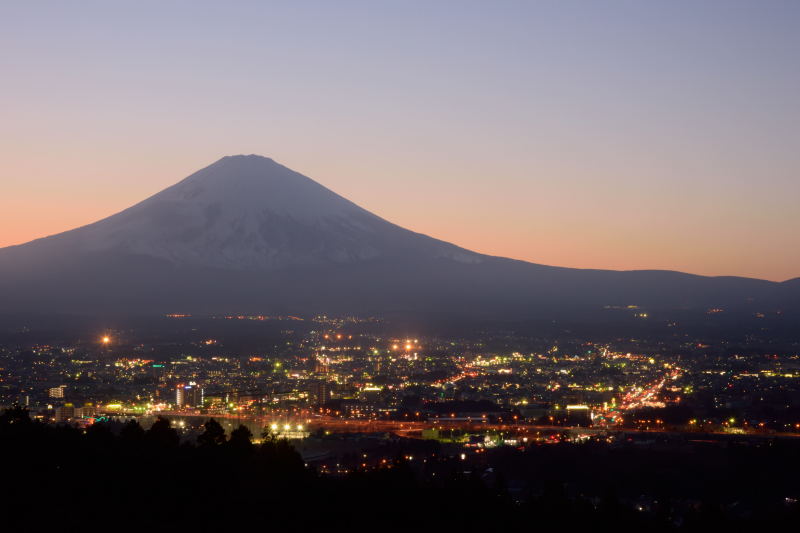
left=0, top=409, right=800, bottom=531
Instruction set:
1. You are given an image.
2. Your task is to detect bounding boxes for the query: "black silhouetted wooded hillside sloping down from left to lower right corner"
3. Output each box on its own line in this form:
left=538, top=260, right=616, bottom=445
left=0, top=408, right=797, bottom=531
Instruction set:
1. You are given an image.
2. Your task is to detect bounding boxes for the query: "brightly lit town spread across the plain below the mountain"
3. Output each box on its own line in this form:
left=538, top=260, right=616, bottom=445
left=0, top=315, right=800, bottom=442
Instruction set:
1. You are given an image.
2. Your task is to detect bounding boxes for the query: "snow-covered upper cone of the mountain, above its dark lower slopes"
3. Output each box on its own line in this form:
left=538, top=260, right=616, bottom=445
left=18, top=155, right=481, bottom=270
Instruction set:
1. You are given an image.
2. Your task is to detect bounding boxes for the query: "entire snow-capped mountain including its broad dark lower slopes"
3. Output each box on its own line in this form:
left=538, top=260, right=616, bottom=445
left=0, top=155, right=797, bottom=318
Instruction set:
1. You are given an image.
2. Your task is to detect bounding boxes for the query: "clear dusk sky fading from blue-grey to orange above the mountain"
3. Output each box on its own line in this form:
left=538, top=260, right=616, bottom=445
left=0, top=0, right=800, bottom=280
